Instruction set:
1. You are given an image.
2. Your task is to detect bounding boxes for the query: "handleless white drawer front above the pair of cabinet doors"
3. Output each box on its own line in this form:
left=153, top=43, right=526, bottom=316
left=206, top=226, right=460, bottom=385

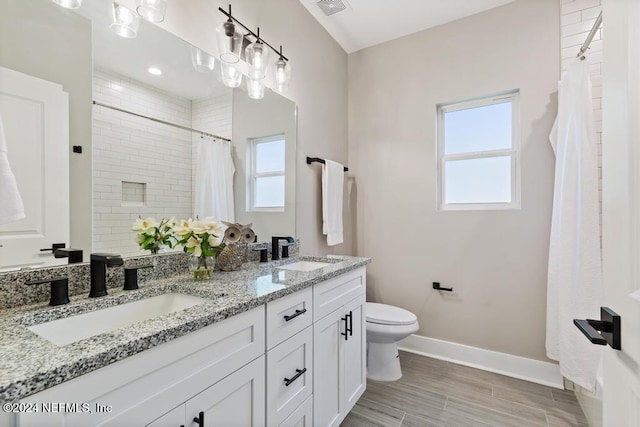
left=313, top=268, right=366, bottom=322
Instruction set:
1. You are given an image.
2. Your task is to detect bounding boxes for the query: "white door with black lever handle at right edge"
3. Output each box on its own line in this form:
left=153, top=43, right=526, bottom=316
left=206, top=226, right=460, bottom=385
left=602, top=0, right=640, bottom=427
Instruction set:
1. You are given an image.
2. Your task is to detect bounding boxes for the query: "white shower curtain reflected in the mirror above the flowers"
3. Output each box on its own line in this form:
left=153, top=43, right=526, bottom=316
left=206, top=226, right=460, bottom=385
left=195, top=139, right=235, bottom=222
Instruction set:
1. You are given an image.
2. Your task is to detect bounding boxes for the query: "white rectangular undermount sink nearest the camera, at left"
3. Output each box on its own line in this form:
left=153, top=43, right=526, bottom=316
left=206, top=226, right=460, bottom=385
left=27, top=292, right=207, bottom=346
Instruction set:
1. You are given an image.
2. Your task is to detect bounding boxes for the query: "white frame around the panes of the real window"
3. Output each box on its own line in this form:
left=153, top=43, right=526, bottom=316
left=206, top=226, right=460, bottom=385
left=436, top=89, right=521, bottom=211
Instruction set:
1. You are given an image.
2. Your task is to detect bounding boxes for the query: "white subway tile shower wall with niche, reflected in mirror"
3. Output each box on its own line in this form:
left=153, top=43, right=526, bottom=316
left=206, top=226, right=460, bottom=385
left=93, top=69, right=232, bottom=256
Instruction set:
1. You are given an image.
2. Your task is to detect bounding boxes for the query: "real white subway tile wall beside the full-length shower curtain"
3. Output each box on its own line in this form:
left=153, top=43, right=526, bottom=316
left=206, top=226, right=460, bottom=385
left=560, top=0, right=605, bottom=228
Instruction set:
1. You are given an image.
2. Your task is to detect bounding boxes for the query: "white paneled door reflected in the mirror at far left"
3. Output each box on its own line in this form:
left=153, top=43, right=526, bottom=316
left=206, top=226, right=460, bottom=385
left=0, top=64, right=68, bottom=271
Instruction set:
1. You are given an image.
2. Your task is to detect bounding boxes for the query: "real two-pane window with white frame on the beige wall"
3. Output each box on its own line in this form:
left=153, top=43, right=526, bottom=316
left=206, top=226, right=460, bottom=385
left=437, top=91, right=520, bottom=210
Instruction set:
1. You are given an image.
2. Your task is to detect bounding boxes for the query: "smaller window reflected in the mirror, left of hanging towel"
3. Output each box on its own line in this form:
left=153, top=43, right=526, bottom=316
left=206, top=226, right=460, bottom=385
left=247, top=134, right=285, bottom=212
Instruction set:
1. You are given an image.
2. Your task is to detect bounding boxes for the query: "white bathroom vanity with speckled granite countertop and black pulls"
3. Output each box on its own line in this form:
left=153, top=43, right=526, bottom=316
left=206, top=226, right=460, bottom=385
left=0, top=256, right=370, bottom=427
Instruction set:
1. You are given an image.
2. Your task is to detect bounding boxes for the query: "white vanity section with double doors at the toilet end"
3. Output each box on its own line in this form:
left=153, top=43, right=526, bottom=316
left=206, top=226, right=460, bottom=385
left=313, top=268, right=367, bottom=426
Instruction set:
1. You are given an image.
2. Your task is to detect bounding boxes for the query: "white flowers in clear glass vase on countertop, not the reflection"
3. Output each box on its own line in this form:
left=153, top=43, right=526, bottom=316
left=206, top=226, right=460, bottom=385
left=173, top=217, right=224, bottom=279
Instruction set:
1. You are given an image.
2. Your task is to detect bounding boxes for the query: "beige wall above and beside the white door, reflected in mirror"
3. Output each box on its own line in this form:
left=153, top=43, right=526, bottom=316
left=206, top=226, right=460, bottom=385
left=0, top=0, right=92, bottom=259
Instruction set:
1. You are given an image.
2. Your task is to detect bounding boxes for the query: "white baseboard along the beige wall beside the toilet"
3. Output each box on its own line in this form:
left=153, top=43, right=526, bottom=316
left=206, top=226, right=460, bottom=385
left=398, top=335, right=564, bottom=389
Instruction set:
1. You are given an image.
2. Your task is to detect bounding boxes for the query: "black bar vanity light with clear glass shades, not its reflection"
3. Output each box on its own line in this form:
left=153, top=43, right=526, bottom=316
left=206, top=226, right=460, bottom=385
left=216, top=5, right=291, bottom=93
